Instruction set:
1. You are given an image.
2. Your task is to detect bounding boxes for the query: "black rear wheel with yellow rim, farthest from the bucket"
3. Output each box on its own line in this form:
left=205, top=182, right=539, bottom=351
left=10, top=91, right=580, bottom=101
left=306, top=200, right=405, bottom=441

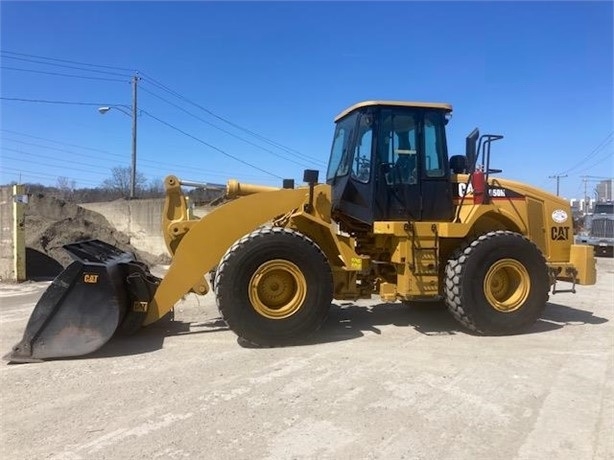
left=444, top=231, right=550, bottom=335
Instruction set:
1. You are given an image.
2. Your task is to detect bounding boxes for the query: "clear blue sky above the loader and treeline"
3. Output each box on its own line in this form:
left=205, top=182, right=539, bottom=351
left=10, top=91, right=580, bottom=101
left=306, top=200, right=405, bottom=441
left=0, top=2, right=614, bottom=197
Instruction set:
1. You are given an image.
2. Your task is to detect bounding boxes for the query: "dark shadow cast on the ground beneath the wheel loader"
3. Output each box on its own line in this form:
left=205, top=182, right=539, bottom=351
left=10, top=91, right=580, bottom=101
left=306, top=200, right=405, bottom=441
left=84, top=303, right=608, bottom=358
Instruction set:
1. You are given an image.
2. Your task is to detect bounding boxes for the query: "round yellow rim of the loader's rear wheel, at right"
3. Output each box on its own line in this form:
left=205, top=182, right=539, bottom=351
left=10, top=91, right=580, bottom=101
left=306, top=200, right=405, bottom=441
left=484, top=259, right=531, bottom=313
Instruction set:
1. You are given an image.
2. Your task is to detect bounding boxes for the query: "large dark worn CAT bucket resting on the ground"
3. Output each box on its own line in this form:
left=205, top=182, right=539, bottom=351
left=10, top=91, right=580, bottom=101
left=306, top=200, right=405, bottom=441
left=4, top=240, right=160, bottom=363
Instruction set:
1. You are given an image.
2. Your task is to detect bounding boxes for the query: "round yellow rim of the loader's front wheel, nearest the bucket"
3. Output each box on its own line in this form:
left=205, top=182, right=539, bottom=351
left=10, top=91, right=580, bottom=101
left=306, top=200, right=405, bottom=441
left=249, top=259, right=307, bottom=319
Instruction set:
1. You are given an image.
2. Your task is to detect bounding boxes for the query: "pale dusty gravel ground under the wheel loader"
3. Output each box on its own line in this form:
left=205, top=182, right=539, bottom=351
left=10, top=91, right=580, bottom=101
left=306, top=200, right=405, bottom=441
left=0, top=259, right=614, bottom=460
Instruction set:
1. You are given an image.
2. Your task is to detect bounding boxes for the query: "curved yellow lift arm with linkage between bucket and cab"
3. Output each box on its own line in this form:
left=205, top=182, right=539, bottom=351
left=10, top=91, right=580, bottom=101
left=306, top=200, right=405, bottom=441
left=152, top=176, right=365, bottom=325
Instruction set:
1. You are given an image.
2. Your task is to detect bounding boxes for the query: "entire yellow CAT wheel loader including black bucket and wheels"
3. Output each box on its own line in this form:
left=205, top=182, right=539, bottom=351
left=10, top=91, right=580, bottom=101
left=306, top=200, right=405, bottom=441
left=7, top=101, right=596, bottom=362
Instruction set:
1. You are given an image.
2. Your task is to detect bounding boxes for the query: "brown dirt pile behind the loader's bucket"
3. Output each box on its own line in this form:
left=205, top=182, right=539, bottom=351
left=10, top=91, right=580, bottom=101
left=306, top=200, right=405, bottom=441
left=25, top=194, right=160, bottom=272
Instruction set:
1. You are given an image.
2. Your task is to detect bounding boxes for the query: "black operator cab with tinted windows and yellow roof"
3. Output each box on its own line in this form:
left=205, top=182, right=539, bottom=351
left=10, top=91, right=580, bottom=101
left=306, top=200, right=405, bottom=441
left=326, top=101, right=454, bottom=224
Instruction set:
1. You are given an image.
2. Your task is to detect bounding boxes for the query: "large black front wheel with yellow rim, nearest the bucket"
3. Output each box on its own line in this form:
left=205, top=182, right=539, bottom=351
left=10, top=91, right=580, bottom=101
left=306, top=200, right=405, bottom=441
left=214, top=228, right=333, bottom=346
